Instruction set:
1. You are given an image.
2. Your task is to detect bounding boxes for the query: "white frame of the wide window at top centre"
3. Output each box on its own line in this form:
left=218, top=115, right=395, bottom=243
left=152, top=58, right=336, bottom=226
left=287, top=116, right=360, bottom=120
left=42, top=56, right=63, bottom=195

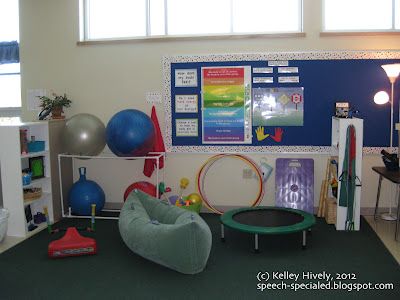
left=78, top=0, right=305, bottom=44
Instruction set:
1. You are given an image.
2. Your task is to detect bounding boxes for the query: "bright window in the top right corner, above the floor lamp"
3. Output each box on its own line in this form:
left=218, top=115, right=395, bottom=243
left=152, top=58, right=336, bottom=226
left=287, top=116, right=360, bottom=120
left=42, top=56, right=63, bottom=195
left=323, top=0, right=400, bottom=31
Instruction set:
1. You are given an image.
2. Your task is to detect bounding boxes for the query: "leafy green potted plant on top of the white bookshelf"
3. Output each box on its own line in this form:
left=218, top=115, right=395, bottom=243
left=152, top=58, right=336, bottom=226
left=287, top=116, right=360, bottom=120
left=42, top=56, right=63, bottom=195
left=38, top=93, right=72, bottom=119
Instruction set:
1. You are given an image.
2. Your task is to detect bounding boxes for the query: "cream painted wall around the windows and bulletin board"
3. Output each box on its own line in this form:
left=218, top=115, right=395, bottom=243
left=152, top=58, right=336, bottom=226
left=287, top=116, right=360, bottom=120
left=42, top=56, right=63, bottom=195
left=20, top=0, right=400, bottom=213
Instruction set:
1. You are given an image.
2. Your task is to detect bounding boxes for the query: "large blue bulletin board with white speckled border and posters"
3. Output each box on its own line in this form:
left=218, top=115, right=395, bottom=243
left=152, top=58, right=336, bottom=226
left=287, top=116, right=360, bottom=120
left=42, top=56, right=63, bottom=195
left=163, top=51, right=400, bottom=153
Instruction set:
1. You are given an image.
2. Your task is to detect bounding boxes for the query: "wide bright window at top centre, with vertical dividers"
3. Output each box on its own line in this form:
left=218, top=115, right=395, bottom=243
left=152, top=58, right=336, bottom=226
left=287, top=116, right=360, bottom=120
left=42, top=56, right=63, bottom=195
left=81, top=0, right=302, bottom=40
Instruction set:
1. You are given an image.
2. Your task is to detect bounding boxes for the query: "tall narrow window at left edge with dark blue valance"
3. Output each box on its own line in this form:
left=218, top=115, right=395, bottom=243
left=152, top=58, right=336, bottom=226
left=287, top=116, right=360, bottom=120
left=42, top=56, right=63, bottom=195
left=0, top=0, right=21, bottom=110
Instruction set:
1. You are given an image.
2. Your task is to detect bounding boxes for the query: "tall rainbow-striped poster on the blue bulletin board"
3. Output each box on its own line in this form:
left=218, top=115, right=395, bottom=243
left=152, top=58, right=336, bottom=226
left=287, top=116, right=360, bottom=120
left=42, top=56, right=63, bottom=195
left=201, top=66, right=251, bottom=144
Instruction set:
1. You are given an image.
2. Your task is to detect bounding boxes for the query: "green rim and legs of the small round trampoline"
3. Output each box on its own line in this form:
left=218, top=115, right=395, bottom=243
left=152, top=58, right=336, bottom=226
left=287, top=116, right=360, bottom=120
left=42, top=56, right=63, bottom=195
left=220, top=206, right=316, bottom=252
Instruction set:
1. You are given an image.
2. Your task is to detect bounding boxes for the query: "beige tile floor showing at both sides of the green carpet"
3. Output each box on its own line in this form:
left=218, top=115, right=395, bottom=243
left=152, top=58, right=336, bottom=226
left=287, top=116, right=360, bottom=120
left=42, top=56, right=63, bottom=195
left=0, top=216, right=400, bottom=264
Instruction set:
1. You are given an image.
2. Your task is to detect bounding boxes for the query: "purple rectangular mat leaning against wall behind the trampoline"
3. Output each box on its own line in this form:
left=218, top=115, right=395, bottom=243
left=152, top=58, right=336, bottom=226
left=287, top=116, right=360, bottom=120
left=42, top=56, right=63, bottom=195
left=275, top=158, right=314, bottom=213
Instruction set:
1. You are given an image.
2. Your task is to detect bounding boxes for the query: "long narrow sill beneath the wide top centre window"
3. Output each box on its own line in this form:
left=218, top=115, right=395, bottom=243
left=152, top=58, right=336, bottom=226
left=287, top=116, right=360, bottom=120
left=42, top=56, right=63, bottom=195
left=77, top=32, right=306, bottom=46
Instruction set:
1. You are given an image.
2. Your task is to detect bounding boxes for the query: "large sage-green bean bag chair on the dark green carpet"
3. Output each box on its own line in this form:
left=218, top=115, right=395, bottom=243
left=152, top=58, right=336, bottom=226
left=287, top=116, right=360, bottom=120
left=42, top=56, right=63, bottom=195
left=118, top=190, right=212, bottom=274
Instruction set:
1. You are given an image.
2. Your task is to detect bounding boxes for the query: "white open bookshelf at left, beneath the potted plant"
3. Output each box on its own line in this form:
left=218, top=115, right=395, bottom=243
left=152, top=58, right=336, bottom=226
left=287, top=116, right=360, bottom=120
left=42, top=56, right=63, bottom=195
left=0, top=122, right=54, bottom=237
